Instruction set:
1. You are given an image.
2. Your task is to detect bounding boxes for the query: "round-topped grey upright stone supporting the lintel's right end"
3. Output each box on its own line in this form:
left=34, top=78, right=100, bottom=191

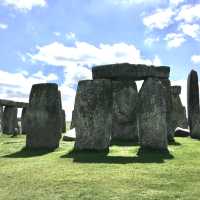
left=138, top=78, right=168, bottom=150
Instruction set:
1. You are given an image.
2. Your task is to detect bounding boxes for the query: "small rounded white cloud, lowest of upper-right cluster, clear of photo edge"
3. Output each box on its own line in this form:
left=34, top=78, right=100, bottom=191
left=164, top=33, right=186, bottom=48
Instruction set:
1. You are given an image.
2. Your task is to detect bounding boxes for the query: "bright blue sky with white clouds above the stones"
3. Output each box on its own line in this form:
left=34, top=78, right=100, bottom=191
left=0, top=0, right=200, bottom=120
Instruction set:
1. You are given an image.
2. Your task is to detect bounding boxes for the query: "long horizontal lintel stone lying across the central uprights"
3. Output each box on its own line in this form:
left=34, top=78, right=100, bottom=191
left=92, top=63, right=170, bottom=80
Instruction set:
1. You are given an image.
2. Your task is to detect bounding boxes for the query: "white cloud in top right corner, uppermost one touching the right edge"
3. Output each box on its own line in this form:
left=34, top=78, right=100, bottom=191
left=175, top=4, right=200, bottom=23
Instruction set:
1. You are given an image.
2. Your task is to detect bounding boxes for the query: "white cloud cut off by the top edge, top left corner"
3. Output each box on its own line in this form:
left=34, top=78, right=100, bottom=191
left=0, top=0, right=47, bottom=11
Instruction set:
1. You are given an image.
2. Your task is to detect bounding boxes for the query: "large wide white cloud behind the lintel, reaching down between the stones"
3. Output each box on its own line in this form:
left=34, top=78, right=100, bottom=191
left=28, top=41, right=161, bottom=120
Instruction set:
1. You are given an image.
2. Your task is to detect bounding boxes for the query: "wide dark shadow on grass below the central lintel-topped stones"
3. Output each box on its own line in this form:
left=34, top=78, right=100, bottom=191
left=61, top=149, right=174, bottom=164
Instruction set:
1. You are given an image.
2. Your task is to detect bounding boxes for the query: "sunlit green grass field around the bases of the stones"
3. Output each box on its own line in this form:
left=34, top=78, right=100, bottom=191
left=0, top=135, right=200, bottom=200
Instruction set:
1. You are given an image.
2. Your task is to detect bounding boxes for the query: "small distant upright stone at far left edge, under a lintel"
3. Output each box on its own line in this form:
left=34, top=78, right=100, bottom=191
left=2, top=106, right=18, bottom=134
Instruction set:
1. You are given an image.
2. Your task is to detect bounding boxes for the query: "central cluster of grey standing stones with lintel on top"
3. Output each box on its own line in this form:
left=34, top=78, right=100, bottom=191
left=71, top=63, right=187, bottom=150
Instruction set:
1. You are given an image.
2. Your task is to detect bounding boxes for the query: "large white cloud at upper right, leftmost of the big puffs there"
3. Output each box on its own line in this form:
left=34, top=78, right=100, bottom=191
left=143, top=8, right=175, bottom=29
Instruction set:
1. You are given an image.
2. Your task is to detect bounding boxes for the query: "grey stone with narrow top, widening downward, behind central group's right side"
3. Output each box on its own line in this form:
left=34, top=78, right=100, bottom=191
left=171, top=86, right=188, bottom=132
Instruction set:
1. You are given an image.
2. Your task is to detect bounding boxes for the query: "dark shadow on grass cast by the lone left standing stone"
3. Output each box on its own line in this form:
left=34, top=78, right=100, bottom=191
left=3, top=147, right=55, bottom=158
